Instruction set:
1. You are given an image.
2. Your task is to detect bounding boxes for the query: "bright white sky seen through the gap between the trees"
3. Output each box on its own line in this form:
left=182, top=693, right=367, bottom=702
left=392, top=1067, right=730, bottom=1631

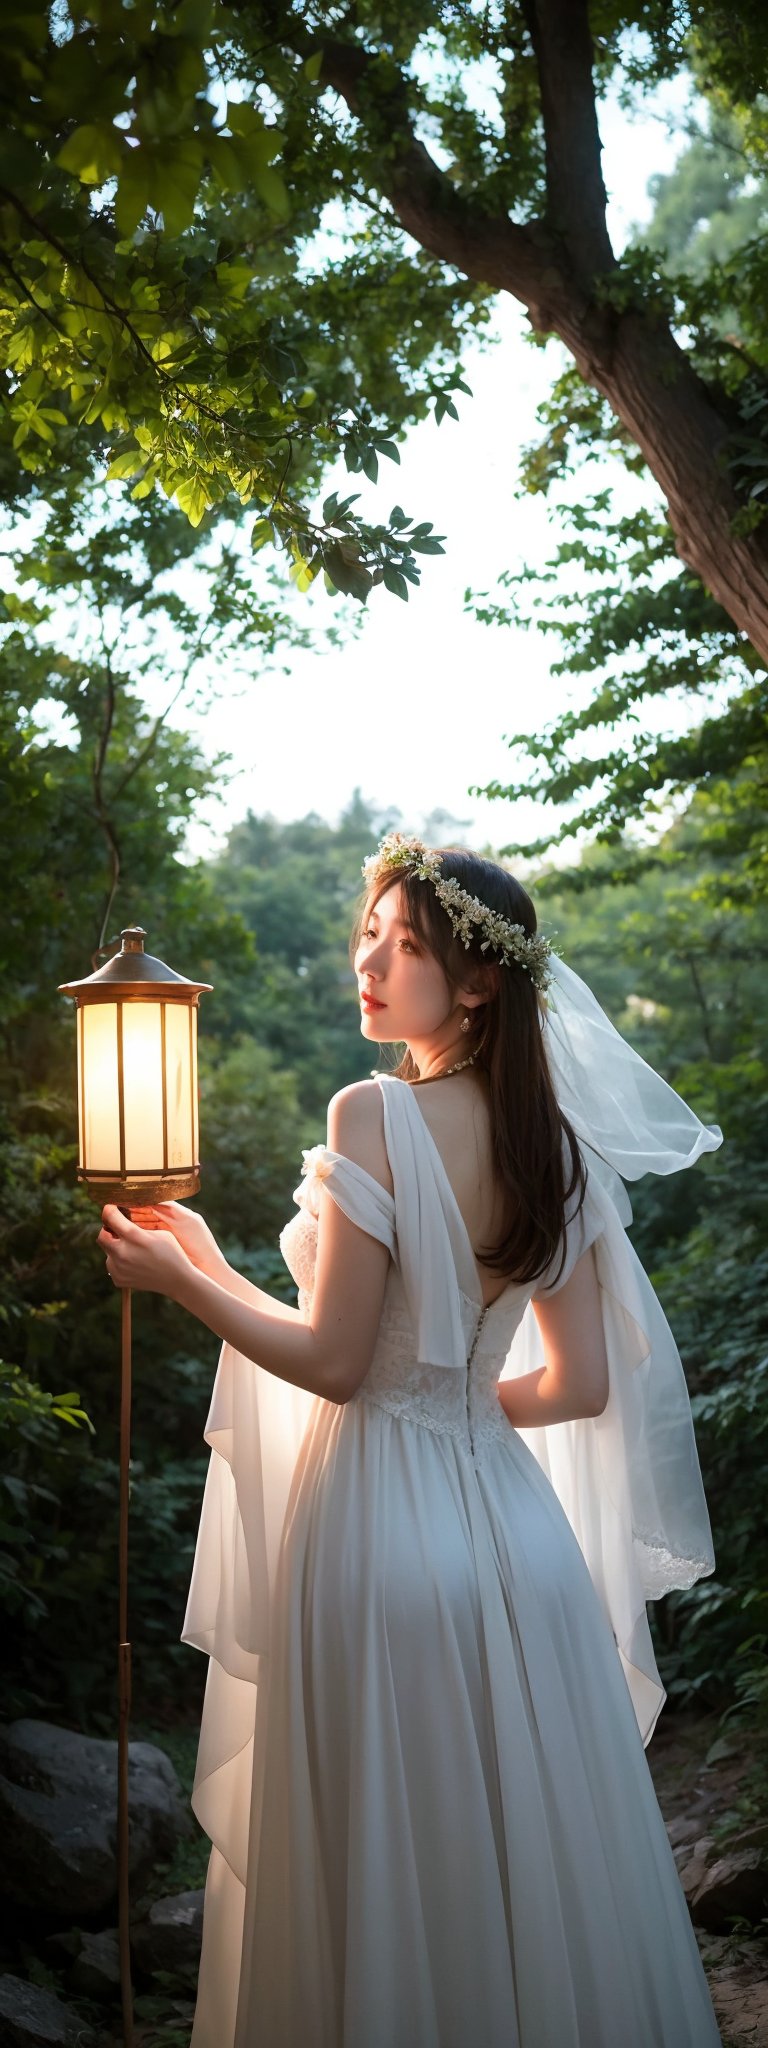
left=179, top=66, right=686, bottom=852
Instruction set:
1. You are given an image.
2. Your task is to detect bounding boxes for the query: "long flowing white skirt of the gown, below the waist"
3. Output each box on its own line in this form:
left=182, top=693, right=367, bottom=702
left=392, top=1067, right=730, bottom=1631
left=195, top=1399, right=721, bottom=2048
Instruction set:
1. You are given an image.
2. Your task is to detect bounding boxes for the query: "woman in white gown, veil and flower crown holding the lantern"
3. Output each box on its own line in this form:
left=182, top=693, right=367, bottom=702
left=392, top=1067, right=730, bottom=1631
left=100, top=834, right=721, bottom=2048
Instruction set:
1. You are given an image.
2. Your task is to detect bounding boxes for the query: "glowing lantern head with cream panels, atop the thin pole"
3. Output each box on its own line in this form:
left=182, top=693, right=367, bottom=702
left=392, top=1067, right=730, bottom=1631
left=59, top=926, right=211, bottom=1206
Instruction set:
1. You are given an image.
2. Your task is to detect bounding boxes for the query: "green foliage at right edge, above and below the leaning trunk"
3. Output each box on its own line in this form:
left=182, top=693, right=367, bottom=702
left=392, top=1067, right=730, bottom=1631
left=467, top=86, right=768, bottom=864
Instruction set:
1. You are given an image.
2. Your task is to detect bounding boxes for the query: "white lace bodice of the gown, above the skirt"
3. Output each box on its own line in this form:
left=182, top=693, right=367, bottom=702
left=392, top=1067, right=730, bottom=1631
left=281, top=1187, right=530, bottom=1460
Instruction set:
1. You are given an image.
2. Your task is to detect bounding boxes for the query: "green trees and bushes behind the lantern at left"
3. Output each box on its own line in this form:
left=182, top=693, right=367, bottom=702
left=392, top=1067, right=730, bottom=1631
left=0, top=508, right=397, bottom=1733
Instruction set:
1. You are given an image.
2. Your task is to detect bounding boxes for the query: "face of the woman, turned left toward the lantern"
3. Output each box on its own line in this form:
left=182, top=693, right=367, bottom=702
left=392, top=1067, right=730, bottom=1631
left=354, top=883, right=461, bottom=1057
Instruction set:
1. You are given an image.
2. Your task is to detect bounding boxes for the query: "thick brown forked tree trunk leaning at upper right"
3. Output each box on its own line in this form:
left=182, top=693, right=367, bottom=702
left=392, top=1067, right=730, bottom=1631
left=313, top=16, right=768, bottom=662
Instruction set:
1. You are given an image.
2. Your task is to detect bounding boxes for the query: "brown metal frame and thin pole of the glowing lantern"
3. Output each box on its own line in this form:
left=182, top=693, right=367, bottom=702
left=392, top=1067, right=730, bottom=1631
left=59, top=924, right=211, bottom=2048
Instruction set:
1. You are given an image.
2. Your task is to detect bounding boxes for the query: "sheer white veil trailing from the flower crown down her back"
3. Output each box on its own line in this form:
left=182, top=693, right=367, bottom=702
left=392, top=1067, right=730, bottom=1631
left=502, top=954, right=723, bottom=1743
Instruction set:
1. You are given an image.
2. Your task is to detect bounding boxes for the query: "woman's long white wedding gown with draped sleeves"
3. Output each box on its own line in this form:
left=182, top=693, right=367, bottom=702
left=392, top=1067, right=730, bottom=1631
left=184, top=1075, right=721, bottom=2048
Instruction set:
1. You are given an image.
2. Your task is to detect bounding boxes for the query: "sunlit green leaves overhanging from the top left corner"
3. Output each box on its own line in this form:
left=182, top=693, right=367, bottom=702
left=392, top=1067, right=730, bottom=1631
left=0, top=0, right=481, bottom=600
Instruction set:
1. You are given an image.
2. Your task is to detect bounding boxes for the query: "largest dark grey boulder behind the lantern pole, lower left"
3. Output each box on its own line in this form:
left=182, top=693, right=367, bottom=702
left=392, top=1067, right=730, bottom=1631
left=0, top=1720, right=193, bottom=1923
